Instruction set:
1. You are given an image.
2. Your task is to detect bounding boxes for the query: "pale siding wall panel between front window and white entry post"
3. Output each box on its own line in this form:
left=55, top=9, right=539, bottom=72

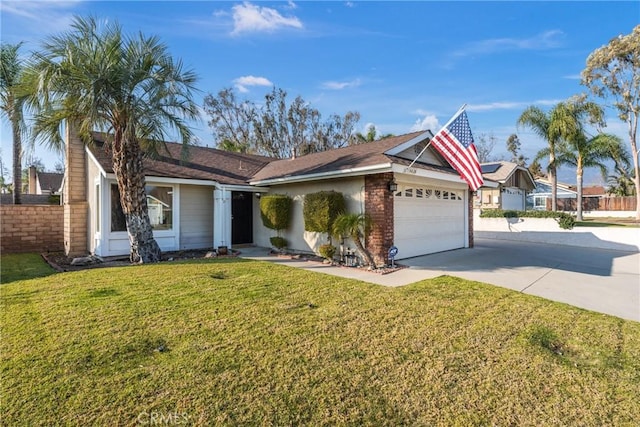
left=180, top=185, right=213, bottom=249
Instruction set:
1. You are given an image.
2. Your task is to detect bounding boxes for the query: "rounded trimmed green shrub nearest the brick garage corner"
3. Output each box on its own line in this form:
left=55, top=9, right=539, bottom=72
left=302, top=190, right=345, bottom=233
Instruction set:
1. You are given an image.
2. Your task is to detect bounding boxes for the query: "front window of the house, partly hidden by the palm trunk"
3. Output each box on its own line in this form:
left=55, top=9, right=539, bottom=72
left=111, top=184, right=173, bottom=231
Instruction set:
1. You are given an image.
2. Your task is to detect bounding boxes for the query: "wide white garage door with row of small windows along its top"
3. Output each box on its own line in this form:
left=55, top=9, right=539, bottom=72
left=393, top=185, right=466, bottom=259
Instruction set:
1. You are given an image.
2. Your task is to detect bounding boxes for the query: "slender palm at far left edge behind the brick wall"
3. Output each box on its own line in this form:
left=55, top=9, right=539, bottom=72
left=0, top=43, right=26, bottom=205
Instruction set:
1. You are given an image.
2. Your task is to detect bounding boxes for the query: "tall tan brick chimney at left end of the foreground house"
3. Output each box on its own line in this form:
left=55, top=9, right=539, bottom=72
left=63, top=123, right=89, bottom=256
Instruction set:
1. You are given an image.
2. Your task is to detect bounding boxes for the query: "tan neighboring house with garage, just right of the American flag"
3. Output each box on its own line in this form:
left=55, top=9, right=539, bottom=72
left=476, top=161, right=536, bottom=211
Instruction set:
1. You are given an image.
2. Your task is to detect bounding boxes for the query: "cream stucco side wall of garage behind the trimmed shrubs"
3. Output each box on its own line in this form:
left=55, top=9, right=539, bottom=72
left=253, top=177, right=364, bottom=252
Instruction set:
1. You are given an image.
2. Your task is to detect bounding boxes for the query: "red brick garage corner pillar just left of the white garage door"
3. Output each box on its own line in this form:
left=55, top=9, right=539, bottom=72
left=364, top=172, right=394, bottom=265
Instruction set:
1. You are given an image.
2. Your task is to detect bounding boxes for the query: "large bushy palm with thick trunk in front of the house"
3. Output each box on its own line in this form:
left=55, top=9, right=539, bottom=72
left=27, top=17, right=198, bottom=263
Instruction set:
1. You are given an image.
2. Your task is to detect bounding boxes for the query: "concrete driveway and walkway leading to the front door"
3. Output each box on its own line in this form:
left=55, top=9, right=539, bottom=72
left=240, top=239, right=640, bottom=321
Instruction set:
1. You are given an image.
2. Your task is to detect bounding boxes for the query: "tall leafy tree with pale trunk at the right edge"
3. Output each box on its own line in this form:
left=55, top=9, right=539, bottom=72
left=582, top=25, right=640, bottom=220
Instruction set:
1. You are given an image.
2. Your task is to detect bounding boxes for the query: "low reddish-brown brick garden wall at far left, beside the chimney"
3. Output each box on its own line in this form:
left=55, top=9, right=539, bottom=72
left=0, top=205, right=64, bottom=253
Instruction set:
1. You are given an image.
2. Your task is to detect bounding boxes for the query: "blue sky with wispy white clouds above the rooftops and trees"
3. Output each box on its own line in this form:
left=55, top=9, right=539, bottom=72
left=0, top=0, right=640, bottom=183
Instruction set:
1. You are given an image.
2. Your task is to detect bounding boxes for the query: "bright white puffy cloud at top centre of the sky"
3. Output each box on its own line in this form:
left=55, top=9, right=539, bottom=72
left=231, top=2, right=303, bottom=35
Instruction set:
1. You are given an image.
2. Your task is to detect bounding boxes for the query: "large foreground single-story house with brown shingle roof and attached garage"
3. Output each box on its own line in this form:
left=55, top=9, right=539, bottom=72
left=65, top=131, right=473, bottom=264
